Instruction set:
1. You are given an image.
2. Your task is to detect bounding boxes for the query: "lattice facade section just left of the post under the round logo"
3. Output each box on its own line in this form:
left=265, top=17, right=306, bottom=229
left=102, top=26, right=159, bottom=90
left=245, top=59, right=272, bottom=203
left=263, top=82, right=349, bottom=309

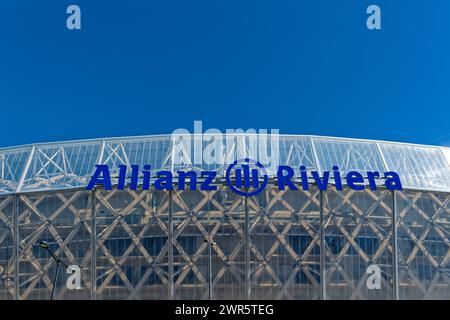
left=173, top=190, right=248, bottom=299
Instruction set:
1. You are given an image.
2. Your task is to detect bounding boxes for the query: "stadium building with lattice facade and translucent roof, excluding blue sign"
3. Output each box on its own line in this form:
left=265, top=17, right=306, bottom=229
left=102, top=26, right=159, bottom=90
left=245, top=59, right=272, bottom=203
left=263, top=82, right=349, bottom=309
left=0, top=134, right=450, bottom=300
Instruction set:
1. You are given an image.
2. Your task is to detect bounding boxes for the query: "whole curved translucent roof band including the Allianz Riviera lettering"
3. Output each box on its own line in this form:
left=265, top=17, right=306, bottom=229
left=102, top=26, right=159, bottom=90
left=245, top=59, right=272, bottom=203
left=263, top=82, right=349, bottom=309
left=4, top=128, right=450, bottom=195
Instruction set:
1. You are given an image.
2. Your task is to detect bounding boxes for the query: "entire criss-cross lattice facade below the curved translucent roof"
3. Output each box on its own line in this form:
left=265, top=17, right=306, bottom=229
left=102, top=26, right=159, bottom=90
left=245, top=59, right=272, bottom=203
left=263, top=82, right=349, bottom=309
left=0, top=188, right=450, bottom=299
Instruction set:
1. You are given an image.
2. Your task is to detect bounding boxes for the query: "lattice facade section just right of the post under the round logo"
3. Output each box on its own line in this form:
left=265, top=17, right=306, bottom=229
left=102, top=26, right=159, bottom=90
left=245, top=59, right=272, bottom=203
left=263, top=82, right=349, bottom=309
left=249, top=189, right=320, bottom=299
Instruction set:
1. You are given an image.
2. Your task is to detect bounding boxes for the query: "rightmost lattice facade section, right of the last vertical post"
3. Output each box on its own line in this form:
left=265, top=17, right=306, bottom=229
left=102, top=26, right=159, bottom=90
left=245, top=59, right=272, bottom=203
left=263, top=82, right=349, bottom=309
left=397, top=192, right=450, bottom=299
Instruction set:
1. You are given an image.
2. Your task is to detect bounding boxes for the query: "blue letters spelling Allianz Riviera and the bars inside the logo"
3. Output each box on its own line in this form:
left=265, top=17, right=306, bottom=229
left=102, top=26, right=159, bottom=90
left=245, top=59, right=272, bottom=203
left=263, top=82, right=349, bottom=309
left=86, top=164, right=403, bottom=194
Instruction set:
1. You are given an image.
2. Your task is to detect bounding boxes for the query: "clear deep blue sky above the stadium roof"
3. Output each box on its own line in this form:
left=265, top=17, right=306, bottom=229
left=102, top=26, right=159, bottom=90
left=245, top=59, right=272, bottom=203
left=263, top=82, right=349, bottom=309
left=0, top=0, right=450, bottom=147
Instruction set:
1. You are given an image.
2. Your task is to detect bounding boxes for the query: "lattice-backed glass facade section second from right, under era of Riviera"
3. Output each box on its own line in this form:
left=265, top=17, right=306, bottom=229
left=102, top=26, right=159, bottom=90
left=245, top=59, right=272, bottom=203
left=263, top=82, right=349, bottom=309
left=324, top=189, right=393, bottom=300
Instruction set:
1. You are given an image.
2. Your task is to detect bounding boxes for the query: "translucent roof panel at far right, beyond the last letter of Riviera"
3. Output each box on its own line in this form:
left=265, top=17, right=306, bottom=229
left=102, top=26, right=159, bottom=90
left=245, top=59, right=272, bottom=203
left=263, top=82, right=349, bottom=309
left=380, top=143, right=450, bottom=191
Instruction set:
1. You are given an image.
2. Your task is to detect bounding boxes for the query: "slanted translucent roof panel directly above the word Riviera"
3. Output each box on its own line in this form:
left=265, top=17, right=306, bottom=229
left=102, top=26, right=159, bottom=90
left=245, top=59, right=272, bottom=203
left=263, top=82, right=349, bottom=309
left=313, top=138, right=386, bottom=174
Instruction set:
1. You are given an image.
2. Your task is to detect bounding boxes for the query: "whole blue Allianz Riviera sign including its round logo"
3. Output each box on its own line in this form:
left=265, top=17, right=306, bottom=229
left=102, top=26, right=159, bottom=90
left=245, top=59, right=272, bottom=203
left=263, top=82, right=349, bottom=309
left=86, top=158, right=403, bottom=196
